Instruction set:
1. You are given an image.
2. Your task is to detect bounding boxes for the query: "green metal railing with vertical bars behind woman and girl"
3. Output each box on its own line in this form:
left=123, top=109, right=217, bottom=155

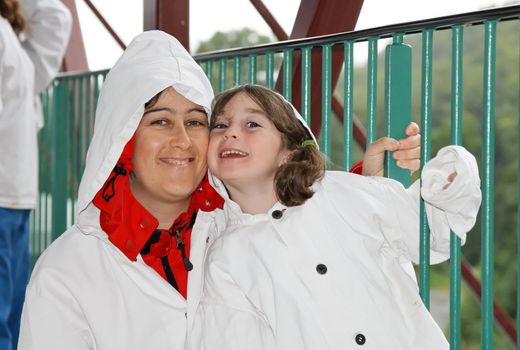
left=31, top=6, right=520, bottom=349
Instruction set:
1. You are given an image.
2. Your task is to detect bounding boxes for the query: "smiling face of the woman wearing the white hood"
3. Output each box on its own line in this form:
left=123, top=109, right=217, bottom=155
left=131, top=88, right=209, bottom=207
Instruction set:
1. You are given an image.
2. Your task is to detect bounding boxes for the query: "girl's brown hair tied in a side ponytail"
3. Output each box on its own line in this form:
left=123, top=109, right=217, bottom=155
left=210, top=84, right=325, bottom=207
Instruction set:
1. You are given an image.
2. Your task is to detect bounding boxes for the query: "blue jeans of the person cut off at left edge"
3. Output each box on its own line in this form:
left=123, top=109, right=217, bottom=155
left=0, top=208, right=30, bottom=350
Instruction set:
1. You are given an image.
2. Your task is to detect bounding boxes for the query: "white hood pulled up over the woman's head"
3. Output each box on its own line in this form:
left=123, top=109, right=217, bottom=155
left=75, top=31, right=213, bottom=222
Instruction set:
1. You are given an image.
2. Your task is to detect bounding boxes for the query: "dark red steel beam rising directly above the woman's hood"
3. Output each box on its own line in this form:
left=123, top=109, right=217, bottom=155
left=143, top=0, right=190, bottom=51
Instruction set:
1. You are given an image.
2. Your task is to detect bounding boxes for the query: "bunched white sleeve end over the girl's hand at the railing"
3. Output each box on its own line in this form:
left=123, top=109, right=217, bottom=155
left=421, top=146, right=482, bottom=252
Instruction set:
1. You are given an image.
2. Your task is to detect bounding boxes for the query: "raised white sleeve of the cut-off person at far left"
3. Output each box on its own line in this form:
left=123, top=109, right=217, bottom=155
left=22, top=0, right=72, bottom=94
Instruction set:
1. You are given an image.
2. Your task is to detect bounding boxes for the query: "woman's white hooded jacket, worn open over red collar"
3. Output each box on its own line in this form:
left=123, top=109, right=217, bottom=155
left=19, top=31, right=216, bottom=350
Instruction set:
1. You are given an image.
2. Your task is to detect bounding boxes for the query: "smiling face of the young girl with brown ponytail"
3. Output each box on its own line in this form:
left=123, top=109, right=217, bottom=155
left=208, top=93, right=289, bottom=188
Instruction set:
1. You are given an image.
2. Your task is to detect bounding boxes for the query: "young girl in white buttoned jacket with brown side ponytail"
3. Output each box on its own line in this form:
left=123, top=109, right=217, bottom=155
left=190, top=85, right=480, bottom=350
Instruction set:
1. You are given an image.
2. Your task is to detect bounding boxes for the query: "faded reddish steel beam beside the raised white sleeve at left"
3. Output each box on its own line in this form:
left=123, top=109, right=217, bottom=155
left=62, top=0, right=88, bottom=72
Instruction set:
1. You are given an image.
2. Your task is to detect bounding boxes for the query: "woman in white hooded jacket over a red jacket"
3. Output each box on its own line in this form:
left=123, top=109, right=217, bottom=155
left=20, top=31, right=221, bottom=349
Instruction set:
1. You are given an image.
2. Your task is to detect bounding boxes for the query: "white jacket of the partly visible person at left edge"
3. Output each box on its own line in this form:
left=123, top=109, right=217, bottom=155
left=0, top=0, right=71, bottom=209
